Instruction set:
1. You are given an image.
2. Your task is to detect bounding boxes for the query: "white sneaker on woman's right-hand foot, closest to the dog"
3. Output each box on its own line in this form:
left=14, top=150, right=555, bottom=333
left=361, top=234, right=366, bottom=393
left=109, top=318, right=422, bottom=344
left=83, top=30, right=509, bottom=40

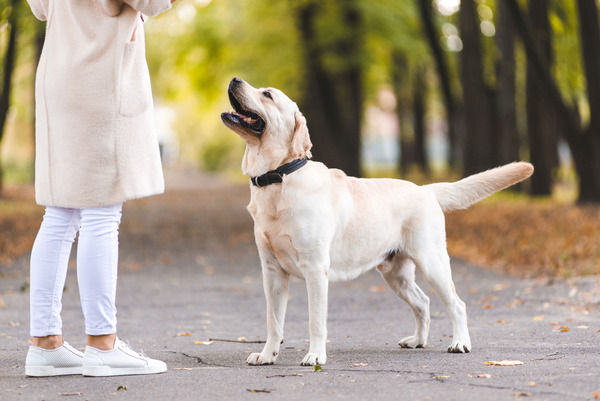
left=83, top=338, right=167, bottom=376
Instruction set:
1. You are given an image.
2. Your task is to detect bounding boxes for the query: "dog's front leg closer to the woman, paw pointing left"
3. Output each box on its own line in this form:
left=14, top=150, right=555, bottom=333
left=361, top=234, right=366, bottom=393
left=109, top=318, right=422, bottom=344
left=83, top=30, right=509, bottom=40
left=246, top=261, right=289, bottom=365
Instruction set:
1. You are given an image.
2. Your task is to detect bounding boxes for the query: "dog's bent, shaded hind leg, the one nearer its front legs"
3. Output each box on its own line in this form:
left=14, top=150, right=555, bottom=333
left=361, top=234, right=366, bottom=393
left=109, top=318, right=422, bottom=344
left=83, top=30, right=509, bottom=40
left=377, top=254, right=430, bottom=348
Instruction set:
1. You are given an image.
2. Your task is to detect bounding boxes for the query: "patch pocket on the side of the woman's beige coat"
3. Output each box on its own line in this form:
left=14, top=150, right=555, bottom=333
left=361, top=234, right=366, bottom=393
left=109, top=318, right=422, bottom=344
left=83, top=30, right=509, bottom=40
left=119, top=41, right=152, bottom=117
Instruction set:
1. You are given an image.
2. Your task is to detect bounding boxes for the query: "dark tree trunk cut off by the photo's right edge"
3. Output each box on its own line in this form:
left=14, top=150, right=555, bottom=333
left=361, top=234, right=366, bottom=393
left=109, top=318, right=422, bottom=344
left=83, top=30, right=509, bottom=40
left=574, top=0, right=600, bottom=202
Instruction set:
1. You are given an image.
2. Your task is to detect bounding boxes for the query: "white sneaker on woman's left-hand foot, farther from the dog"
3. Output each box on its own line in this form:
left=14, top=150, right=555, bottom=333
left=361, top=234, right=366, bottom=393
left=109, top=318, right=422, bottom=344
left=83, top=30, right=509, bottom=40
left=25, top=341, right=83, bottom=376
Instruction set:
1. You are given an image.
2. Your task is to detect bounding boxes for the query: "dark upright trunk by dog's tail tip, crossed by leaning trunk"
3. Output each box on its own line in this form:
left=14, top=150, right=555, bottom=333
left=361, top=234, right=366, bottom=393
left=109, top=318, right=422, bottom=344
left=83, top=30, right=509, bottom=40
left=526, top=0, right=558, bottom=195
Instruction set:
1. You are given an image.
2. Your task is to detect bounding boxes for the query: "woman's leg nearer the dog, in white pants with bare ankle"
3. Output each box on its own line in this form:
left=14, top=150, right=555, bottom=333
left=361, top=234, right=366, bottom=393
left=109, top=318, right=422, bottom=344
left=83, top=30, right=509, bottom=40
left=77, top=204, right=123, bottom=349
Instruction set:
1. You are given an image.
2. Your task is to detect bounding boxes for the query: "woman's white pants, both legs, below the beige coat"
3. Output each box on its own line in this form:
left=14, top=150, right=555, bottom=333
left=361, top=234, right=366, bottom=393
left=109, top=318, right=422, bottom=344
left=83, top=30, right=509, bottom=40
left=30, top=204, right=123, bottom=337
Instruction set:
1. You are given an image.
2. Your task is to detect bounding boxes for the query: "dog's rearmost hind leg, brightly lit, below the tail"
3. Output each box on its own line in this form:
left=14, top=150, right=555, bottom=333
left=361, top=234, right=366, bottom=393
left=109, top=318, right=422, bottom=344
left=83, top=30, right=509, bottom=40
left=415, top=248, right=471, bottom=353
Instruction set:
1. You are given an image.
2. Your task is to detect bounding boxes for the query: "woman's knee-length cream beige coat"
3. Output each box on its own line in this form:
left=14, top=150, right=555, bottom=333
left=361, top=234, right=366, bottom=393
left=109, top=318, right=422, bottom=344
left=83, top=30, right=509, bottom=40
left=28, top=0, right=171, bottom=208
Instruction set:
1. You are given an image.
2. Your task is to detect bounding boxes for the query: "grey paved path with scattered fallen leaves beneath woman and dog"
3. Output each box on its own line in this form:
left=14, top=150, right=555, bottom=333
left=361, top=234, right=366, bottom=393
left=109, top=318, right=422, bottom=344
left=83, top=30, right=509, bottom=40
left=0, top=170, right=600, bottom=401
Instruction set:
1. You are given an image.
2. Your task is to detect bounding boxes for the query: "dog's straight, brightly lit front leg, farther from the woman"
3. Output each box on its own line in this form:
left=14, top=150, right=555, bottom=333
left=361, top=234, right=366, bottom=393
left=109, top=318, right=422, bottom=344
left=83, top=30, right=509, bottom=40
left=301, top=268, right=329, bottom=366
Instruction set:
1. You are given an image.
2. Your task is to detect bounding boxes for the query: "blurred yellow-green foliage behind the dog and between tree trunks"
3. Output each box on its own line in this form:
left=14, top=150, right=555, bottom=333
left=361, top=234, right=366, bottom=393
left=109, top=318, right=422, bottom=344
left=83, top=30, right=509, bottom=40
left=0, top=0, right=588, bottom=183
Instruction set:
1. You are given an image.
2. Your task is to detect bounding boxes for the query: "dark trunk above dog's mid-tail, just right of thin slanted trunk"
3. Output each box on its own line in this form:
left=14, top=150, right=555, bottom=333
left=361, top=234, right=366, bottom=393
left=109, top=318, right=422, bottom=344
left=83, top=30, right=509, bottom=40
left=459, top=0, right=495, bottom=175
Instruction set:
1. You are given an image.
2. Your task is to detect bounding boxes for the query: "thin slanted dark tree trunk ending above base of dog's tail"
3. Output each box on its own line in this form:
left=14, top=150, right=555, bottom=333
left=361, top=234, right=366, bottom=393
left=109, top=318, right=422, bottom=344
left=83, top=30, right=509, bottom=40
left=416, top=0, right=462, bottom=167
